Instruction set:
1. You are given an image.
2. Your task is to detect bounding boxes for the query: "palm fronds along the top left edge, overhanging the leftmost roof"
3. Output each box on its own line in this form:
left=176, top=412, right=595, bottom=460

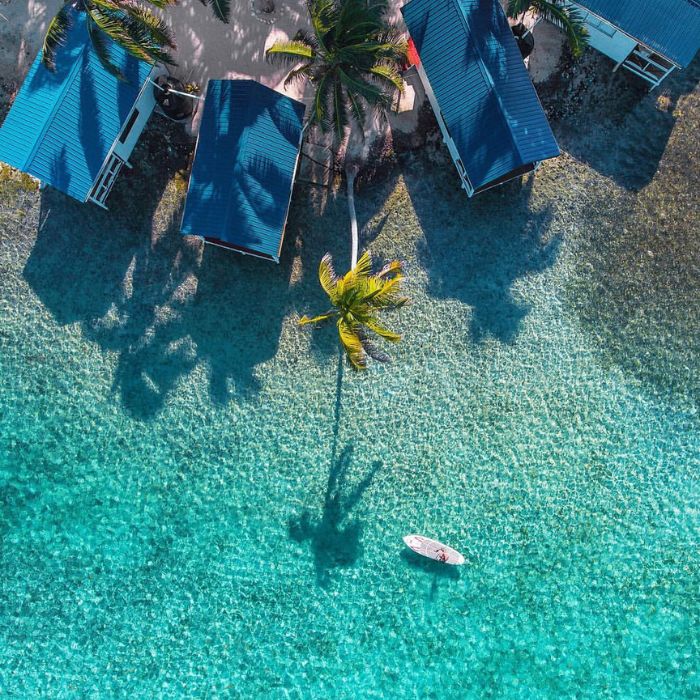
left=42, top=0, right=230, bottom=79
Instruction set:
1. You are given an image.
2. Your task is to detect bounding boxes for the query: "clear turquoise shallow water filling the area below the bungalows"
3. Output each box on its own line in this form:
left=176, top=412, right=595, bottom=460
left=0, top=95, right=700, bottom=698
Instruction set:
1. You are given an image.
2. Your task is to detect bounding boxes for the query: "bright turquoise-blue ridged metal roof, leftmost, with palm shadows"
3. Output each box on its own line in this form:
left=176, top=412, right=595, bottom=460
left=0, top=12, right=152, bottom=202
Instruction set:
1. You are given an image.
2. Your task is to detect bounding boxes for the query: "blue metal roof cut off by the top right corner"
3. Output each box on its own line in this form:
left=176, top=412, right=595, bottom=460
left=575, top=0, right=700, bottom=68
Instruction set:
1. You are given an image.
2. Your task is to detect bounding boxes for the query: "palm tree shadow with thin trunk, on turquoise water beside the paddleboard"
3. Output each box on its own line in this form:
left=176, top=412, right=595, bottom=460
left=288, top=357, right=382, bottom=588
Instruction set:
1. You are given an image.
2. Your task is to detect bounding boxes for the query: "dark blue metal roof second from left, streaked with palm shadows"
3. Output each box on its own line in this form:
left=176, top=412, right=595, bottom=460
left=182, top=80, right=304, bottom=260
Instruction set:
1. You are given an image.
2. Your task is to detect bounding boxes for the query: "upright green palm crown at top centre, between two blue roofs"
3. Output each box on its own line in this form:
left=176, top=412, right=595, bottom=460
left=266, top=0, right=406, bottom=141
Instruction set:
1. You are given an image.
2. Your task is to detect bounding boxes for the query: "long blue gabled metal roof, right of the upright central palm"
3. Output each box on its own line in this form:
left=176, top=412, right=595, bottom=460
left=401, top=0, right=559, bottom=189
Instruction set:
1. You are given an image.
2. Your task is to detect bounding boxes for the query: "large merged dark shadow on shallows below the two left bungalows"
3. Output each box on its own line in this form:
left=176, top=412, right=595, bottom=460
left=24, top=119, right=291, bottom=420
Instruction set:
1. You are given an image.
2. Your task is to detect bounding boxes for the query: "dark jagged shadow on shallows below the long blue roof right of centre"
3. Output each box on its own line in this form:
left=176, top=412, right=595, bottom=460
left=404, top=168, right=560, bottom=343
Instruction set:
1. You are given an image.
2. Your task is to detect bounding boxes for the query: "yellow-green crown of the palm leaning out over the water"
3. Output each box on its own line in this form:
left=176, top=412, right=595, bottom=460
left=299, top=252, right=408, bottom=369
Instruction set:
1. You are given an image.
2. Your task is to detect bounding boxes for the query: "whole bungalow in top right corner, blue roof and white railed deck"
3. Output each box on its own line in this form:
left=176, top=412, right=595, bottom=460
left=568, top=0, right=700, bottom=89
